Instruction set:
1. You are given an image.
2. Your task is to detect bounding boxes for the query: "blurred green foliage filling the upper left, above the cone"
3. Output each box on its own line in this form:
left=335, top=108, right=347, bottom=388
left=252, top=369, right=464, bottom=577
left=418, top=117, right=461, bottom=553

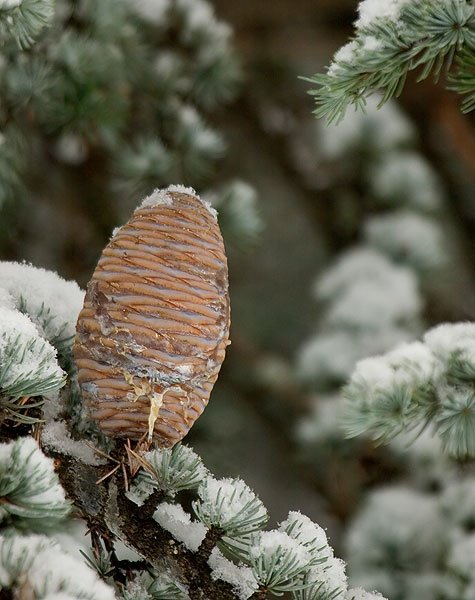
left=0, top=0, right=259, bottom=258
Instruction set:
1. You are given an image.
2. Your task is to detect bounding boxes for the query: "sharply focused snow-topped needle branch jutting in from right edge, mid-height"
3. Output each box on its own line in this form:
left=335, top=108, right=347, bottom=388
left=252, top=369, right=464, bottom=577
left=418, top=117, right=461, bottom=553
left=344, top=323, right=475, bottom=458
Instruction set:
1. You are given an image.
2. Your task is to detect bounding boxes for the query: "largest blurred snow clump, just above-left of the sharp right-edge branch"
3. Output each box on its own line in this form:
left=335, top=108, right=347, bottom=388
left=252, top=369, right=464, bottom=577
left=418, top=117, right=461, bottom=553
left=297, top=246, right=422, bottom=389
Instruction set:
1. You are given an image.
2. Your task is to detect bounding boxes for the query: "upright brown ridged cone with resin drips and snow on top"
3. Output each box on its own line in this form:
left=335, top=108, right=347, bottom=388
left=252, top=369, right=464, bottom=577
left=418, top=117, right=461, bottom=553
left=74, top=186, right=230, bottom=446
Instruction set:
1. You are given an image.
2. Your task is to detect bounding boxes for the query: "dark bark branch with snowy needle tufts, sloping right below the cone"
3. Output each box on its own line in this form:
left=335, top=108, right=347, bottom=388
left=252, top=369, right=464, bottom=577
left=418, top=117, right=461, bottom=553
left=37, top=436, right=388, bottom=600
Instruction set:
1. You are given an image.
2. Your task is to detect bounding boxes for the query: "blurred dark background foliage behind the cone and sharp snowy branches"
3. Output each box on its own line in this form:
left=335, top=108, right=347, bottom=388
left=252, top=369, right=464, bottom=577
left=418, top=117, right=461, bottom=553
left=0, top=0, right=475, bottom=600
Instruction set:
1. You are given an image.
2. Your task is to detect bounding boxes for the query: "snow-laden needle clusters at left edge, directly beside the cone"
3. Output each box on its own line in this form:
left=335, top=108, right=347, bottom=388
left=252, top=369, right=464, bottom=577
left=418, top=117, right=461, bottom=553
left=0, top=262, right=84, bottom=423
